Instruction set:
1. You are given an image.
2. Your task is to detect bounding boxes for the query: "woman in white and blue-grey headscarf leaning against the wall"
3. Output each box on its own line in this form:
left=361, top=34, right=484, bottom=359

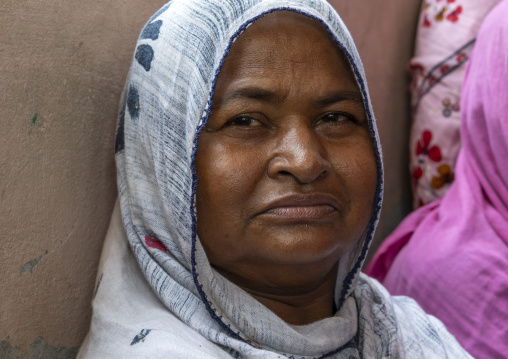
left=80, top=0, right=469, bottom=359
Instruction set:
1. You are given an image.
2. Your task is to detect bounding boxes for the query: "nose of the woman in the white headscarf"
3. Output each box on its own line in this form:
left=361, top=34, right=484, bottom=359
left=268, top=125, right=331, bottom=184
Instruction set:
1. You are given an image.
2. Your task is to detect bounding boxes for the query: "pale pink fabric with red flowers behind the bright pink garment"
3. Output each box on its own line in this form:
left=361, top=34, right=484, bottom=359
left=409, top=0, right=500, bottom=208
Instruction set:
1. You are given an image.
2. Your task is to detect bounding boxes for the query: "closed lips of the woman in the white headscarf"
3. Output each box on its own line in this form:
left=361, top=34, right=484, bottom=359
left=260, top=194, right=338, bottom=221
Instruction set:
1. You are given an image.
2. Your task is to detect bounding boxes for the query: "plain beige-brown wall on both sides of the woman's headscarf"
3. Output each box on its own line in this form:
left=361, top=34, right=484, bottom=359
left=0, top=0, right=420, bottom=359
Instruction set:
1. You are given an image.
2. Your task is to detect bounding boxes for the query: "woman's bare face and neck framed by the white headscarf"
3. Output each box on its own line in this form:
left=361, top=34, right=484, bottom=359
left=196, top=12, right=377, bottom=325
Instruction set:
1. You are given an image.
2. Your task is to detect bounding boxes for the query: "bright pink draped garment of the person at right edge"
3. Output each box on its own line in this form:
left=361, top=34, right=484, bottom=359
left=366, top=0, right=508, bottom=358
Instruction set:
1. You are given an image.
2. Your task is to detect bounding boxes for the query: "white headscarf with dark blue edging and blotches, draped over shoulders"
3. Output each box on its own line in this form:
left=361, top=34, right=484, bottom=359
left=81, top=0, right=472, bottom=359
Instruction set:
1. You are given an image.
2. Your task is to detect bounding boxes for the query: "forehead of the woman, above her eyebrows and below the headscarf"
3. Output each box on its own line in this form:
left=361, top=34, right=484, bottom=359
left=213, top=11, right=361, bottom=108
